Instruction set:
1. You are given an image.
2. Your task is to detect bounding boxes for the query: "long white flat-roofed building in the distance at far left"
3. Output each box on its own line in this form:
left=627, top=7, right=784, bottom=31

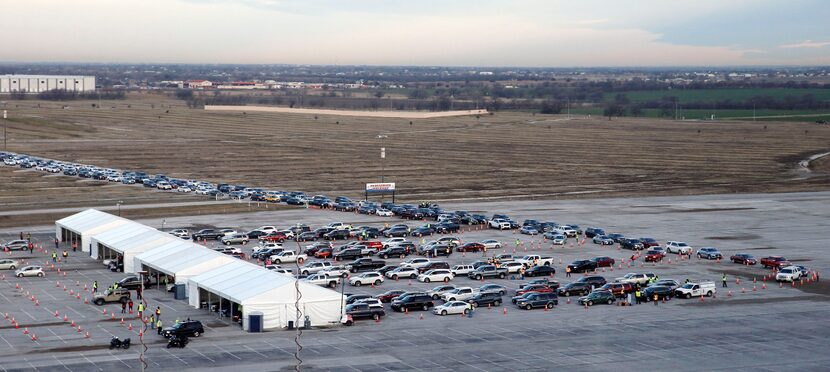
left=0, top=75, right=95, bottom=93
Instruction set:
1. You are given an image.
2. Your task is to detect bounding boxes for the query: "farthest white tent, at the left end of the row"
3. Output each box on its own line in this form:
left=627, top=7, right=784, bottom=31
left=55, top=209, right=130, bottom=252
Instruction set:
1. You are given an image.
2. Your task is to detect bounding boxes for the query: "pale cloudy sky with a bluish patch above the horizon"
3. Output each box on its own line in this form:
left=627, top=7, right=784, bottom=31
left=0, top=0, right=830, bottom=67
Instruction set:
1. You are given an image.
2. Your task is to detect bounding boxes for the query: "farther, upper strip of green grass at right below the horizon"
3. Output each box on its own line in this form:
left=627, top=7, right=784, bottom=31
left=603, top=88, right=830, bottom=103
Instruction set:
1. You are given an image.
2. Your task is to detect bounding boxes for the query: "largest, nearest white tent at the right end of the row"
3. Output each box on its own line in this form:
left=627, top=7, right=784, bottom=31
left=188, top=260, right=343, bottom=330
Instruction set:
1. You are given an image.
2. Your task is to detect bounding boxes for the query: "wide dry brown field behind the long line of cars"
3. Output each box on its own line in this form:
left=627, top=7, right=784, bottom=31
left=0, top=95, right=830, bottom=219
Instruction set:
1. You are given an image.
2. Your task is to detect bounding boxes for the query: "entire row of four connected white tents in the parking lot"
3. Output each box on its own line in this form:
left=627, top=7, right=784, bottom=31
left=55, top=209, right=344, bottom=331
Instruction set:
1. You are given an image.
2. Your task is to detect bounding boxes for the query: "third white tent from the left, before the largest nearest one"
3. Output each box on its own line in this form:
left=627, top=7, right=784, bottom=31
left=134, top=241, right=238, bottom=285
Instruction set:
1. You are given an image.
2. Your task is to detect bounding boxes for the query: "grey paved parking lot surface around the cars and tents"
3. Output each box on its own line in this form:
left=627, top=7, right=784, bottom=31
left=0, top=193, right=830, bottom=371
